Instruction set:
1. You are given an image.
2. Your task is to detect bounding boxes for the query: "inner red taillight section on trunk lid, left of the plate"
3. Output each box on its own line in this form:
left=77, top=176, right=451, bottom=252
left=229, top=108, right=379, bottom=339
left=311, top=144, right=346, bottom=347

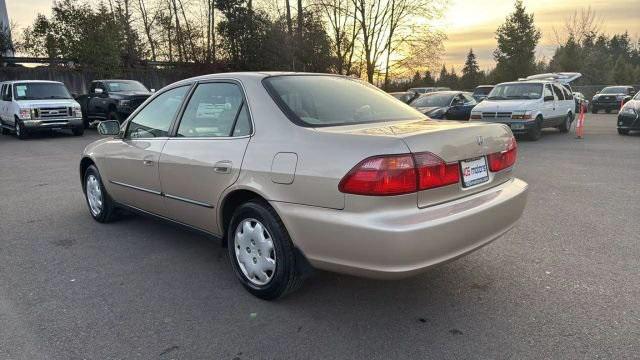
left=414, top=152, right=460, bottom=190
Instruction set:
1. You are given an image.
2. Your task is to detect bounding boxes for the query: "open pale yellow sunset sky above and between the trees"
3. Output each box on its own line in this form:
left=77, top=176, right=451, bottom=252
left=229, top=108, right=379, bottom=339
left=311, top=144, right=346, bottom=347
left=5, top=0, right=640, bottom=72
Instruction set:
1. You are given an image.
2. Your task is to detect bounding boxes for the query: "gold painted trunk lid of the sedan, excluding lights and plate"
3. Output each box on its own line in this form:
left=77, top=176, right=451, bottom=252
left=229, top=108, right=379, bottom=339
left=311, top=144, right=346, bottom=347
left=316, top=120, right=513, bottom=207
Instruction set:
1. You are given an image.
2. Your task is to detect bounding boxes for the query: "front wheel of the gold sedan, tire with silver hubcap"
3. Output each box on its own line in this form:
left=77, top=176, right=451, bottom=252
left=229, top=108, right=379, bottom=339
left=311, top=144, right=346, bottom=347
left=82, top=165, right=116, bottom=223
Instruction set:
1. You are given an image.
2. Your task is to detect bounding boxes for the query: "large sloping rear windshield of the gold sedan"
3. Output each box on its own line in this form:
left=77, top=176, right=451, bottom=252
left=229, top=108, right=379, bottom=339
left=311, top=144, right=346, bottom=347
left=264, top=75, right=425, bottom=127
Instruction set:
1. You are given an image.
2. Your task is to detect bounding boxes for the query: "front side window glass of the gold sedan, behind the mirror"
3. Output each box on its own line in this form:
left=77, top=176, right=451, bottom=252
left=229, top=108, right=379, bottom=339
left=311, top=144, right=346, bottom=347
left=125, top=86, right=189, bottom=139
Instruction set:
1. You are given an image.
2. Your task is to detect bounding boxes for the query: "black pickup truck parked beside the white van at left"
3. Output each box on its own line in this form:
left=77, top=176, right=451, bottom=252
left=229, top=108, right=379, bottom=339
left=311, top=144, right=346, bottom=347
left=76, top=80, right=153, bottom=127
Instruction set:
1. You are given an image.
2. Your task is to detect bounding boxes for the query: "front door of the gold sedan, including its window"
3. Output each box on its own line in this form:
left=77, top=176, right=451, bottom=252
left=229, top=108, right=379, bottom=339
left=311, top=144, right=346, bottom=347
left=105, top=86, right=190, bottom=216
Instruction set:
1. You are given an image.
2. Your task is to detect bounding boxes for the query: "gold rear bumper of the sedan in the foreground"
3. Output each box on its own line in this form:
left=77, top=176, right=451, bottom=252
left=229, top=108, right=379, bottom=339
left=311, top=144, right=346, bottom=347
left=272, top=179, right=527, bottom=279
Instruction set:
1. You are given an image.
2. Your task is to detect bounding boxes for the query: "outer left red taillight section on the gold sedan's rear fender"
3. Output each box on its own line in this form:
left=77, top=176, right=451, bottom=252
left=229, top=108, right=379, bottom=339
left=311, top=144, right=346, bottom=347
left=338, top=154, right=417, bottom=196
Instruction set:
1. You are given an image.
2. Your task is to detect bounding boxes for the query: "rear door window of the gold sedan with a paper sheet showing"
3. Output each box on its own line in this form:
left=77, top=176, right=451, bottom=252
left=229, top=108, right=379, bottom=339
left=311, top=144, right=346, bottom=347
left=177, top=83, right=244, bottom=137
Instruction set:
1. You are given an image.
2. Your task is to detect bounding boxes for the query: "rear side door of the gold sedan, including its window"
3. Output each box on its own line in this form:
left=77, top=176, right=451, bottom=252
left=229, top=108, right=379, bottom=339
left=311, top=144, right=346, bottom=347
left=160, top=81, right=251, bottom=235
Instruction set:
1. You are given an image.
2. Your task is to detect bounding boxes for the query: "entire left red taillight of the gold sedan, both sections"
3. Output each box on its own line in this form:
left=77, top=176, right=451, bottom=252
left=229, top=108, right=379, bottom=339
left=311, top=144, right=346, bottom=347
left=338, top=152, right=460, bottom=196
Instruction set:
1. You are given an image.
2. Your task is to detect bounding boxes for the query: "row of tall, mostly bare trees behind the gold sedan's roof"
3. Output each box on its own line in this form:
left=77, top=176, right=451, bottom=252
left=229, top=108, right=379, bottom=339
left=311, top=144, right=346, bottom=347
left=6, top=0, right=445, bottom=85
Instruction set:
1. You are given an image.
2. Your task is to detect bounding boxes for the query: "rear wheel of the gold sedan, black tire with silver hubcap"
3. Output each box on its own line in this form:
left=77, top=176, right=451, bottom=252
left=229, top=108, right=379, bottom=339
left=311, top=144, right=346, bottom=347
left=227, top=200, right=302, bottom=300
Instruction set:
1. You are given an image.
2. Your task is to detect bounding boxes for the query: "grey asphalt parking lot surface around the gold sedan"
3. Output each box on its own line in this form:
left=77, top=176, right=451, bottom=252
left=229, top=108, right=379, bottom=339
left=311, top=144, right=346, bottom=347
left=0, top=114, right=640, bottom=359
